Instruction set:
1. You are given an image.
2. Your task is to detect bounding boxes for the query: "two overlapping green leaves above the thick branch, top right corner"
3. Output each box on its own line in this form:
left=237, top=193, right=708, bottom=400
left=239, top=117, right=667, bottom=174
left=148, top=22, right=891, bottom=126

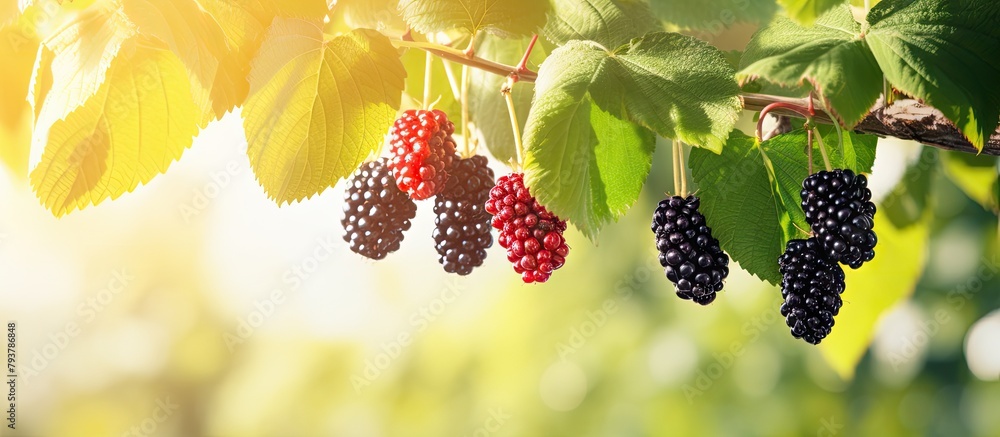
left=740, top=0, right=1000, bottom=149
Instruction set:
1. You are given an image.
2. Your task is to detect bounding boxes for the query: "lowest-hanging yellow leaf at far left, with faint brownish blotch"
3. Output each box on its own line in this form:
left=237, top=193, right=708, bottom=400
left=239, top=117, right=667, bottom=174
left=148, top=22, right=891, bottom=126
left=31, top=36, right=200, bottom=216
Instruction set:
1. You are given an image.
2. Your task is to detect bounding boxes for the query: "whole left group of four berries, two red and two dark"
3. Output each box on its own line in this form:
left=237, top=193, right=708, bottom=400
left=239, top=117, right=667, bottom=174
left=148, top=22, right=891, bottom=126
left=341, top=110, right=569, bottom=282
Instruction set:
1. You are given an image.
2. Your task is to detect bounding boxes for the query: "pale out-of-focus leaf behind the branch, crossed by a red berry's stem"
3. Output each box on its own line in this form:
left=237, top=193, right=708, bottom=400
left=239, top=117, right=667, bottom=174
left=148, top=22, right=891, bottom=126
left=468, top=38, right=546, bottom=162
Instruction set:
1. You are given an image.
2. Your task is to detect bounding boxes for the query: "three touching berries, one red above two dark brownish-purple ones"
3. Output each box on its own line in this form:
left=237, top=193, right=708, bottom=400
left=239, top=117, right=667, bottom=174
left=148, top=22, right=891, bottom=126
left=341, top=110, right=493, bottom=275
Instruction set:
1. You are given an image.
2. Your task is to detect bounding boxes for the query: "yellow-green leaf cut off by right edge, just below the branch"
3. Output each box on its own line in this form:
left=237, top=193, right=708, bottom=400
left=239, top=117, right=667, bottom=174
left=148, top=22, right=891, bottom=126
left=941, top=152, right=1000, bottom=212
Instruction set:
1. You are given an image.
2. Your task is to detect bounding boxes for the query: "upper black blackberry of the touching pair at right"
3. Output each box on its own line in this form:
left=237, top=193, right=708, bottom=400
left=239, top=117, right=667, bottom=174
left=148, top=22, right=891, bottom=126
left=801, top=169, right=878, bottom=269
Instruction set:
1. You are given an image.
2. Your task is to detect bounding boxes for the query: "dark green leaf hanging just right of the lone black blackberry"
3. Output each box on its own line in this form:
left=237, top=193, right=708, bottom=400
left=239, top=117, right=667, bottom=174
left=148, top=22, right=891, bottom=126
left=689, top=130, right=785, bottom=284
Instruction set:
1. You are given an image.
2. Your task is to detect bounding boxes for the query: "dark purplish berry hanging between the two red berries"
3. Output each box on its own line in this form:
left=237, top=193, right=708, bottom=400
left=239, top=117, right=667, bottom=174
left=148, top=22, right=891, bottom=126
left=433, top=155, right=493, bottom=276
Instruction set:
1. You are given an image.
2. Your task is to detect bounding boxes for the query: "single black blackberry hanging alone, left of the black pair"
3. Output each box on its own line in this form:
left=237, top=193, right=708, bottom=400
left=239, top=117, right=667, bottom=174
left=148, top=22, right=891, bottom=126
left=650, top=196, right=729, bottom=305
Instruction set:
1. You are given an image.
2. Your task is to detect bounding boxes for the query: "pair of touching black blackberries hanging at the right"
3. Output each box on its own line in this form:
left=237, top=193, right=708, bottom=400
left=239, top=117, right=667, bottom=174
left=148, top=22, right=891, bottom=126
left=778, top=169, right=878, bottom=344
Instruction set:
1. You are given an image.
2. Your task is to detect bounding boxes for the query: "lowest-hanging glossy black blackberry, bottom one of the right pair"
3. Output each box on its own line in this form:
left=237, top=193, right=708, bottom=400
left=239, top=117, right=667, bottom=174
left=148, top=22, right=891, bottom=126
left=778, top=237, right=844, bottom=344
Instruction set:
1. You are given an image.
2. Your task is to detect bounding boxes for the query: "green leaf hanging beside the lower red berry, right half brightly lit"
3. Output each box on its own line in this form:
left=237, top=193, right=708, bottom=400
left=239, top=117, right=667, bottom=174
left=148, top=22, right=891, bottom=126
left=524, top=47, right=656, bottom=240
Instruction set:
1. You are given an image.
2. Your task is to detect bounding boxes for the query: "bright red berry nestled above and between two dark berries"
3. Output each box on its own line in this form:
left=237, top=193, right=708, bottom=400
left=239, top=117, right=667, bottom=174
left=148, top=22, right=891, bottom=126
left=389, top=109, right=455, bottom=200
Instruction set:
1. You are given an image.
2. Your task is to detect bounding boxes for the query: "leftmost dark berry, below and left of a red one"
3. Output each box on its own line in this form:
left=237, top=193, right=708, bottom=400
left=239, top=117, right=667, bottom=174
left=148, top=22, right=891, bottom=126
left=341, top=158, right=417, bottom=259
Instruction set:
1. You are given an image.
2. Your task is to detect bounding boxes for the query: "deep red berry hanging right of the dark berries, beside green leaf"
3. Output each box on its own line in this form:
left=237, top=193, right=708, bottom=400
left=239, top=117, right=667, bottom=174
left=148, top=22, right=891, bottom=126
left=486, top=173, right=569, bottom=283
